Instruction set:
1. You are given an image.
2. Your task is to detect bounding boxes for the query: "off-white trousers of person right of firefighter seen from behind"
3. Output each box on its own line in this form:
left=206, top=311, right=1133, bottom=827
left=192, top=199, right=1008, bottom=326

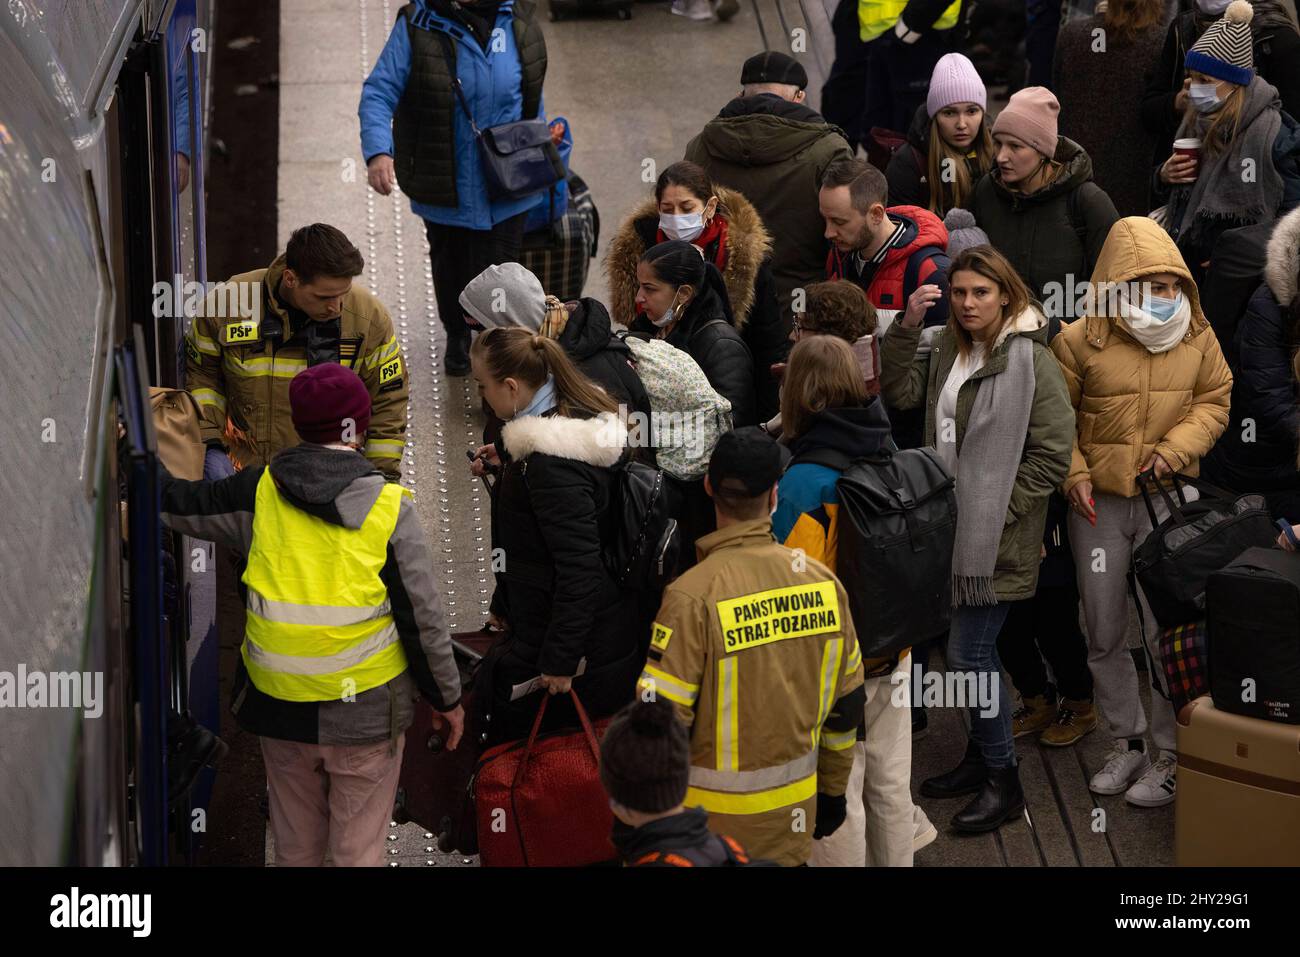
left=809, top=654, right=915, bottom=867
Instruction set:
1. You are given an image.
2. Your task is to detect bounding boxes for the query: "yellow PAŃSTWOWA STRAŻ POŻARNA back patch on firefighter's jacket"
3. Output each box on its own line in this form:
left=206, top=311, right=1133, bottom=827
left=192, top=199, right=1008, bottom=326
left=718, top=581, right=841, bottom=654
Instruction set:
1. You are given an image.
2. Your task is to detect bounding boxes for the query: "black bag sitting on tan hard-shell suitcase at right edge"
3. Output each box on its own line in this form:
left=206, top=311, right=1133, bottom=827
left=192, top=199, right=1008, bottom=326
left=1205, top=547, right=1300, bottom=724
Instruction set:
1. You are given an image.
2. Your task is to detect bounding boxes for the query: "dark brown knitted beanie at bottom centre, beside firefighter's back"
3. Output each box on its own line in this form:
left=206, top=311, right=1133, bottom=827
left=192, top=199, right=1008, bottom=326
left=601, top=698, right=690, bottom=814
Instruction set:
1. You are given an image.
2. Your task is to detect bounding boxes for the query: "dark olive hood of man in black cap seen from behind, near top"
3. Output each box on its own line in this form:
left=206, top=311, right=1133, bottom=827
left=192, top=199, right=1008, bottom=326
left=699, top=94, right=844, bottom=166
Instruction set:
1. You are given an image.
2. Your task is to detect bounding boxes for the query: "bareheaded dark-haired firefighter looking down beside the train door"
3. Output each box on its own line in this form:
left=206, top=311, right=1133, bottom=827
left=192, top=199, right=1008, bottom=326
left=185, top=222, right=408, bottom=481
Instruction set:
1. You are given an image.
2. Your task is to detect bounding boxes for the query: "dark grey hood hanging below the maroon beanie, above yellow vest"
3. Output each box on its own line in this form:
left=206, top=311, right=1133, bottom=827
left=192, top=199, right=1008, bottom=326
left=270, top=442, right=384, bottom=528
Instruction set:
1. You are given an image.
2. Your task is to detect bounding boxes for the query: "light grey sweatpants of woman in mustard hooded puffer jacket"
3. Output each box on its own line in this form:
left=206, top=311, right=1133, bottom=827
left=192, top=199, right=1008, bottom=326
left=1070, top=488, right=1197, bottom=752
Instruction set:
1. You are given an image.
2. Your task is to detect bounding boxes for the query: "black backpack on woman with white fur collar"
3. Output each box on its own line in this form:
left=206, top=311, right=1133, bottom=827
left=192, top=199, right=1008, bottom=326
left=603, top=458, right=681, bottom=592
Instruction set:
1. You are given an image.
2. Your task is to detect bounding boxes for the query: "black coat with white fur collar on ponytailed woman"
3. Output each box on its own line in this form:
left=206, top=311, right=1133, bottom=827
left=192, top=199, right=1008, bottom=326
left=490, top=413, right=650, bottom=741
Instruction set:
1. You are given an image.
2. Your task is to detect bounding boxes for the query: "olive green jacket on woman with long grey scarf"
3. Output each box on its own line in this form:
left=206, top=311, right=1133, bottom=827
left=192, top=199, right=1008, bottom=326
left=880, top=309, right=1075, bottom=601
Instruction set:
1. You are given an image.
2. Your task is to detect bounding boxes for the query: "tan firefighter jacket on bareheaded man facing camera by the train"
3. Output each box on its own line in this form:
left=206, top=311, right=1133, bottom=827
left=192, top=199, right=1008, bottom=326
left=185, top=256, right=408, bottom=481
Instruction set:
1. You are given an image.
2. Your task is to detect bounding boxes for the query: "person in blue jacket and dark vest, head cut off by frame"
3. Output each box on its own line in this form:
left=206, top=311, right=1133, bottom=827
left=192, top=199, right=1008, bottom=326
left=358, top=0, right=546, bottom=376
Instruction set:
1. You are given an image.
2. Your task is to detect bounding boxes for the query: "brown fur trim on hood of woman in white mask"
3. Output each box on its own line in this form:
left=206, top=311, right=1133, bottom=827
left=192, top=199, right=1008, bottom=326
left=605, top=186, right=772, bottom=329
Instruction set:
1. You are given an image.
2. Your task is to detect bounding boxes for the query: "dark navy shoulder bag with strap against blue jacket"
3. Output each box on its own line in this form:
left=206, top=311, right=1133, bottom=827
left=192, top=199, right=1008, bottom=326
left=436, top=30, right=567, bottom=199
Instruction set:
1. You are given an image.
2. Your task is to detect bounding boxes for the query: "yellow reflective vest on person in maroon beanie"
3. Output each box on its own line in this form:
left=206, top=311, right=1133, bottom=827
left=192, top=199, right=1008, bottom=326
left=239, top=468, right=410, bottom=701
